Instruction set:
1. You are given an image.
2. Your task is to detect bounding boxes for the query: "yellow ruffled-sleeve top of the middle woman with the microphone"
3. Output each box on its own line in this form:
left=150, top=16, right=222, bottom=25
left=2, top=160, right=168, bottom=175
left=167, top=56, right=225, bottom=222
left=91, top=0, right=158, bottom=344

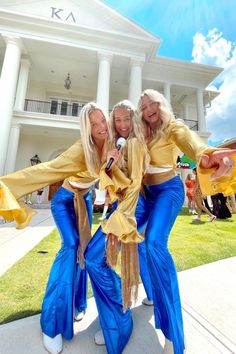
left=100, top=138, right=146, bottom=243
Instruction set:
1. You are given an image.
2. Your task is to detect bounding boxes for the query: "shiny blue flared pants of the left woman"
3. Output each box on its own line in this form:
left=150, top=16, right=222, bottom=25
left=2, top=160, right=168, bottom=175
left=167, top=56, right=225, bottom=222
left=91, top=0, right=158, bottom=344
left=40, top=187, right=92, bottom=340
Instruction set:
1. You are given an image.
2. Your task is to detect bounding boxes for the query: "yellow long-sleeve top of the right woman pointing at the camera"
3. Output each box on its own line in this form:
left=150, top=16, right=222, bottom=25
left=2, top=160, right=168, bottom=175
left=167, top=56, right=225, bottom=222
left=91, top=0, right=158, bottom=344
left=148, top=120, right=236, bottom=195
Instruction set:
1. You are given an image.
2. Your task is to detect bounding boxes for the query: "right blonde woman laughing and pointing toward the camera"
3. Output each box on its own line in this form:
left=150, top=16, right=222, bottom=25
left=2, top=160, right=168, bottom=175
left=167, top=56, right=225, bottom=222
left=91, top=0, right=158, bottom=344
left=137, top=89, right=236, bottom=354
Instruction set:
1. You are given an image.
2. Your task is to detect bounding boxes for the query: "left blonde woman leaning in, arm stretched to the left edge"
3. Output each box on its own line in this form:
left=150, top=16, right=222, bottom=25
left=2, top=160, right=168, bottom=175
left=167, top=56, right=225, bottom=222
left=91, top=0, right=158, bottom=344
left=0, top=102, right=108, bottom=354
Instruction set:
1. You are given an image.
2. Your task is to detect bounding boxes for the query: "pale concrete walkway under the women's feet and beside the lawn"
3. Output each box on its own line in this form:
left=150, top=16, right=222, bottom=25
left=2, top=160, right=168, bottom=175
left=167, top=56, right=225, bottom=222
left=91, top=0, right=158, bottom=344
left=0, top=210, right=236, bottom=354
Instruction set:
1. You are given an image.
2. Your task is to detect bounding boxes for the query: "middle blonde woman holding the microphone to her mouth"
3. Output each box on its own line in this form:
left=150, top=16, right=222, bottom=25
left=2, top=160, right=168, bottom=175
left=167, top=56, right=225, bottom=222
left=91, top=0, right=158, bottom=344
left=85, top=100, right=152, bottom=354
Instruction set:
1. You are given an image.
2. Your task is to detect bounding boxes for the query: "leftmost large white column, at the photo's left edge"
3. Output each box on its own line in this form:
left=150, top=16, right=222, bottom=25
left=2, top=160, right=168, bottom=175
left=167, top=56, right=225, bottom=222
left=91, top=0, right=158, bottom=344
left=0, top=37, right=21, bottom=175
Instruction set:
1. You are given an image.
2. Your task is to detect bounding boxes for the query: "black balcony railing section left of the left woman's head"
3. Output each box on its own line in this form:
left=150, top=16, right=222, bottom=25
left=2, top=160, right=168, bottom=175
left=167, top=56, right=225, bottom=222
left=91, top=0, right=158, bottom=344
left=24, top=99, right=86, bottom=117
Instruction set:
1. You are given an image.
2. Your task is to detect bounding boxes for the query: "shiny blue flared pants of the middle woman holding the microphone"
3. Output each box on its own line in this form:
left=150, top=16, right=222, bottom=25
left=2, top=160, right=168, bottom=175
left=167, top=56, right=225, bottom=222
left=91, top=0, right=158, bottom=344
left=85, top=195, right=153, bottom=354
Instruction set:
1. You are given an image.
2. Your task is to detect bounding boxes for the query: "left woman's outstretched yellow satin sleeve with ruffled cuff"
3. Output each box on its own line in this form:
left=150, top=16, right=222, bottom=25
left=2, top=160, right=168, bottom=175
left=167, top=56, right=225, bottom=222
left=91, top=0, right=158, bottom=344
left=0, top=141, right=86, bottom=228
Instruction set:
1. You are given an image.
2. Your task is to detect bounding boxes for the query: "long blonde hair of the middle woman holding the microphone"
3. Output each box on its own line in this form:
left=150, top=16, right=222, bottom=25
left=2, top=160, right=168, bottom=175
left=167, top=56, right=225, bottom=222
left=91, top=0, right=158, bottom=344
left=108, top=100, right=150, bottom=170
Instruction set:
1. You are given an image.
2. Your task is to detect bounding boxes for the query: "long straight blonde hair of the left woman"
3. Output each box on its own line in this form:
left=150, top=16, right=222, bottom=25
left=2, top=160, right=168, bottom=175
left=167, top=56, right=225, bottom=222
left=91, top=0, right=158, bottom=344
left=79, top=102, right=108, bottom=177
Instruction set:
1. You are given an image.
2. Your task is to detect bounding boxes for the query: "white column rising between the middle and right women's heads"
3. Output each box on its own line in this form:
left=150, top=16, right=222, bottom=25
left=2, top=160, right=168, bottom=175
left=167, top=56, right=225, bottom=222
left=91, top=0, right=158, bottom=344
left=129, top=58, right=143, bottom=106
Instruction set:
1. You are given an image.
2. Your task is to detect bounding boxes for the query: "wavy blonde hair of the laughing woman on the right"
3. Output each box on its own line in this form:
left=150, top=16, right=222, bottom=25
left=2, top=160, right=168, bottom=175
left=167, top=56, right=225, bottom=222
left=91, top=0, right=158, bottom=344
left=138, top=89, right=175, bottom=138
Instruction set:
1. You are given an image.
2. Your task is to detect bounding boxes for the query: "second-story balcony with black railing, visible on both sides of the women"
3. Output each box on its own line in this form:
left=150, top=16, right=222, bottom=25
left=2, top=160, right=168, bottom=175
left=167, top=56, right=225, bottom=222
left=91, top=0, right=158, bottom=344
left=24, top=99, right=198, bottom=131
